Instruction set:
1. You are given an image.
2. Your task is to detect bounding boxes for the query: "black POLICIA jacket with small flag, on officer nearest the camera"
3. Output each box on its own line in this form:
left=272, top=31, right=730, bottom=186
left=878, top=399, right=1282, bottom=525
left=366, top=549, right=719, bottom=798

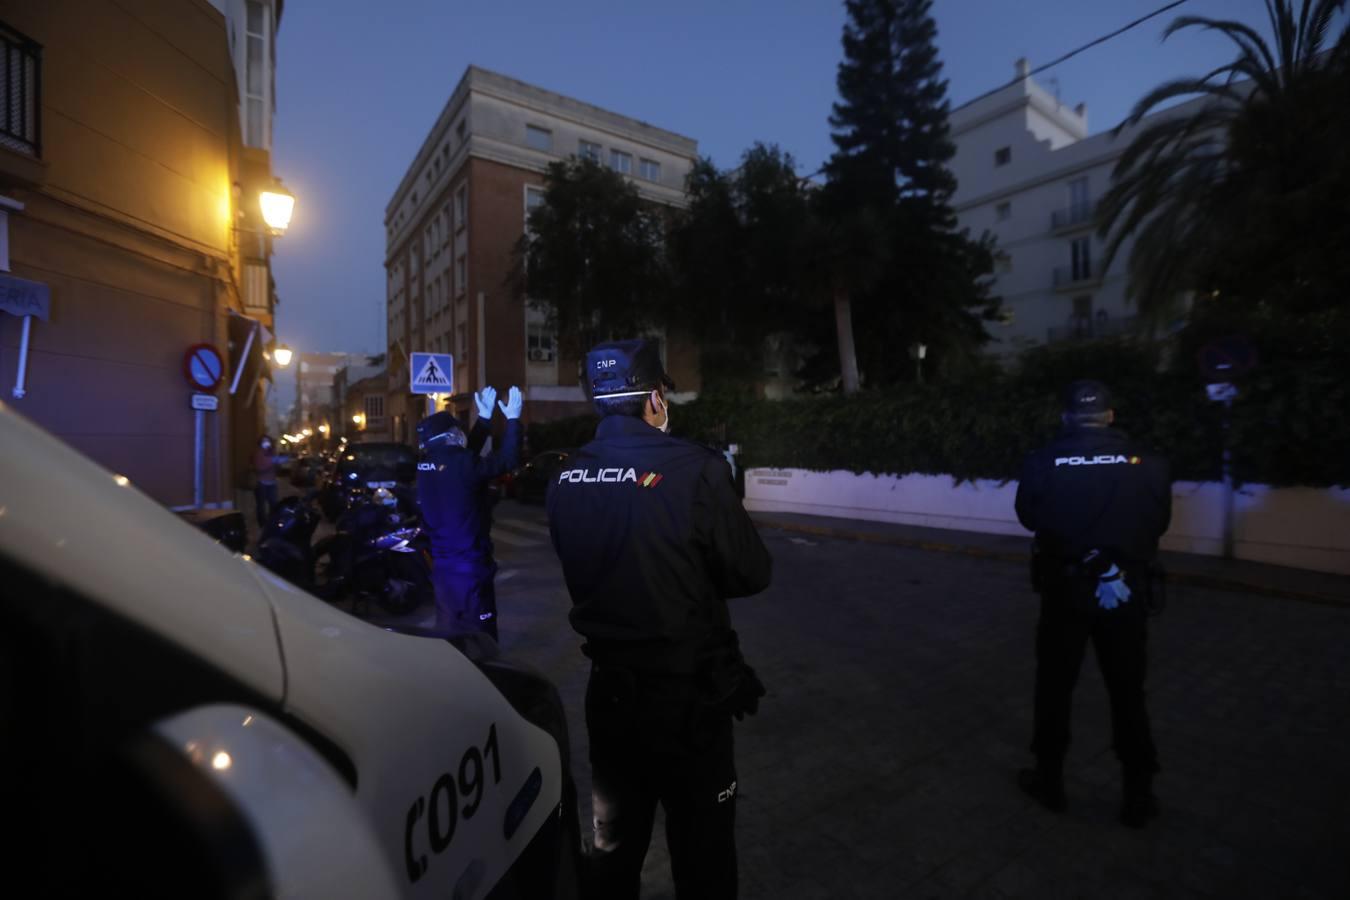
left=548, top=416, right=772, bottom=668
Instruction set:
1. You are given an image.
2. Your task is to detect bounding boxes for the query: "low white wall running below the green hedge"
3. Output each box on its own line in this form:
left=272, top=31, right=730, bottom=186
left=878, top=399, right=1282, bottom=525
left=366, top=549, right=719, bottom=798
left=745, top=468, right=1350, bottom=575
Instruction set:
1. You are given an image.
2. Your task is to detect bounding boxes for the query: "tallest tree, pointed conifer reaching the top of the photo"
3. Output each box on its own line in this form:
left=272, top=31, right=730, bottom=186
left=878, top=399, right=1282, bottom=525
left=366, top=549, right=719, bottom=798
left=819, top=0, right=996, bottom=391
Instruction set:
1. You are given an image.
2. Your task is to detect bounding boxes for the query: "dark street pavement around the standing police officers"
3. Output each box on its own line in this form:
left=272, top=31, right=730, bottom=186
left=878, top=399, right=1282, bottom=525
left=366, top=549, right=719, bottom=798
left=378, top=503, right=1350, bottom=900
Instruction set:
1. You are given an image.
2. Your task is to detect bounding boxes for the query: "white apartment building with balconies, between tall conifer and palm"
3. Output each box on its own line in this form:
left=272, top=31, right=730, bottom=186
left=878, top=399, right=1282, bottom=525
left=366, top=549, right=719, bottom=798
left=950, top=59, right=1199, bottom=355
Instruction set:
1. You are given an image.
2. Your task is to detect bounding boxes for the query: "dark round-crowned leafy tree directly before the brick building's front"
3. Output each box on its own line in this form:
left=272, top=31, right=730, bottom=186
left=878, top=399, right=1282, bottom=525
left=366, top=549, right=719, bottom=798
left=516, top=159, right=667, bottom=354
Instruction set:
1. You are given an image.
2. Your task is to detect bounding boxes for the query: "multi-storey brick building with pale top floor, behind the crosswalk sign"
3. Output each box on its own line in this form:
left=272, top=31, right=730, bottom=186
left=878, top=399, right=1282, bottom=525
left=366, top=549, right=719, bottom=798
left=385, top=66, right=698, bottom=441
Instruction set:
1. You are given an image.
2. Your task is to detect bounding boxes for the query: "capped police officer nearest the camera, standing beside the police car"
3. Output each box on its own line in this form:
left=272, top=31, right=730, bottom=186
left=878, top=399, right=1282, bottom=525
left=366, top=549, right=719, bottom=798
left=548, top=340, right=771, bottom=900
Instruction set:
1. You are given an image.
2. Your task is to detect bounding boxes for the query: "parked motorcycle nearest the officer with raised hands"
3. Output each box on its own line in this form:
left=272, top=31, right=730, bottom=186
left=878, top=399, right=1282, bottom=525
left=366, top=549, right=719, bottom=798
left=312, top=487, right=432, bottom=615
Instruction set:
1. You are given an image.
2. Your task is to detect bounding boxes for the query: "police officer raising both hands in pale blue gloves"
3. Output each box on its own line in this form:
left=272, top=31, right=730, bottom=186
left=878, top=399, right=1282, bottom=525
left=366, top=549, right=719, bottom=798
left=417, top=387, right=522, bottom=640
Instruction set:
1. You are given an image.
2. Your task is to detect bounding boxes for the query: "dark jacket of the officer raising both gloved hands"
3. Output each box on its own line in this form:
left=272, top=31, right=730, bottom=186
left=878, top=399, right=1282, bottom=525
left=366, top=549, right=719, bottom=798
left=417, top=418, right=521, bottom=572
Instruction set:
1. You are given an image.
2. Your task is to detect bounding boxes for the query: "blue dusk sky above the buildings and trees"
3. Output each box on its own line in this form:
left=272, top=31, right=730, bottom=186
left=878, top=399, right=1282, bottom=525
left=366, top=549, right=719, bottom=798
left=265, top=0, right=1269, bottom=401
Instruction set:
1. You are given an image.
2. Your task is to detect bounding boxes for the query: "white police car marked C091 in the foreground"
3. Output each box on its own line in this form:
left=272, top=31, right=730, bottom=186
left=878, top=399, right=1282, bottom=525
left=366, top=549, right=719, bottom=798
left=0, top=403, right=579, bottom=900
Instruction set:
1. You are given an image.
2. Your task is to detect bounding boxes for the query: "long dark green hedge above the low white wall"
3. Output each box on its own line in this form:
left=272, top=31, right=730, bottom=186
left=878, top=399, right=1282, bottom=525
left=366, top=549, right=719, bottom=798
left=529, top=345, right=1350, bottom=487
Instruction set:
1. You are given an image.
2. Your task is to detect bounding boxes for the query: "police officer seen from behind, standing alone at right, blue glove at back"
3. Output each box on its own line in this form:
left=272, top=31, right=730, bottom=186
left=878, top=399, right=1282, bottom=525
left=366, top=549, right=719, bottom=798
left=1017, top=382, right=1172, bottom=827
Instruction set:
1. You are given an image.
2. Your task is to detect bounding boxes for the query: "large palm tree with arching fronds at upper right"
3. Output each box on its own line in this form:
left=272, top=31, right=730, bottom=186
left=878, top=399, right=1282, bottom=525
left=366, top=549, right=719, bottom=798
left=1098, top=0, right=1350, bottom=324
